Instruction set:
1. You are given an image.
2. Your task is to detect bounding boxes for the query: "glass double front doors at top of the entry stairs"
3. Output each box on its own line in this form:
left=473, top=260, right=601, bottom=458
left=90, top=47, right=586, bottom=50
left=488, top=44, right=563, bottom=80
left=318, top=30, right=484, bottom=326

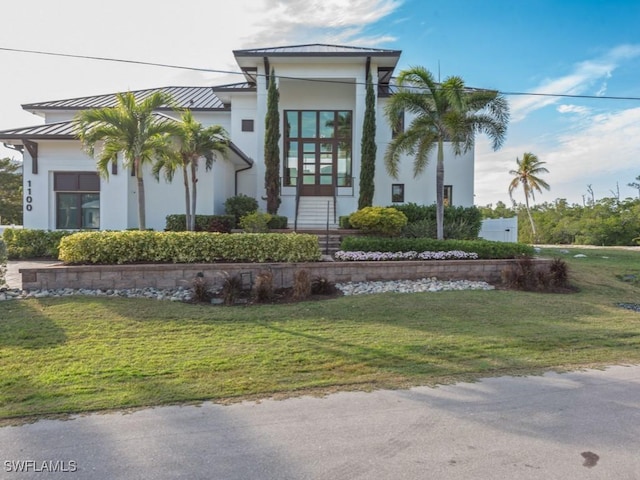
left=298, top=141, right=336, bottom=197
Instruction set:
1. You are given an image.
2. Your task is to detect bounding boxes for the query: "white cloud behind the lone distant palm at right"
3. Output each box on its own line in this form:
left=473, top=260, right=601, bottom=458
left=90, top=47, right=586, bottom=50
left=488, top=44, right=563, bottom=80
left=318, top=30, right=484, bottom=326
left=475, top=106, right=640, bottom=205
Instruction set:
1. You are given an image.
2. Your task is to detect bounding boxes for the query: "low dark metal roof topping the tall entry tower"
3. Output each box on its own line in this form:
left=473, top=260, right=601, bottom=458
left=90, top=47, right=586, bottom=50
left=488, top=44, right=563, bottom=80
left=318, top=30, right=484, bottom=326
left=233, top=43, right=402, bottom=57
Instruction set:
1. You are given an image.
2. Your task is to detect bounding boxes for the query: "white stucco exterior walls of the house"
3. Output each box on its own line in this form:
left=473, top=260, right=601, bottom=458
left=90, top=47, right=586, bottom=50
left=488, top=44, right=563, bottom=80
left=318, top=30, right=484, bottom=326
left=13, top=58, right=474, bottom=230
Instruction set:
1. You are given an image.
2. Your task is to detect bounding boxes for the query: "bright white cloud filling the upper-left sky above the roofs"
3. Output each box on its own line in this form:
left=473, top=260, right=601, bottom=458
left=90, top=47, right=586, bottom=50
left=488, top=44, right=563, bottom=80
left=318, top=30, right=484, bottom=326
left=0, top=0, right=403, bottom=157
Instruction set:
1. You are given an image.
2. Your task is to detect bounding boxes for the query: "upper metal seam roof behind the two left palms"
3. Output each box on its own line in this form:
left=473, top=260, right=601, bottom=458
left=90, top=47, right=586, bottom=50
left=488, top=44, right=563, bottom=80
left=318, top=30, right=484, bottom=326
left=22, top=83, right=252, bottom=111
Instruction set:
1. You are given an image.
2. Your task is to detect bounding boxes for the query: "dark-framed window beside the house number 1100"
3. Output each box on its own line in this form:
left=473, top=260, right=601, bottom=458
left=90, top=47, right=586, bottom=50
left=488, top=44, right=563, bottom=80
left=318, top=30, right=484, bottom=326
left=53, top=172, right=100, bottom=230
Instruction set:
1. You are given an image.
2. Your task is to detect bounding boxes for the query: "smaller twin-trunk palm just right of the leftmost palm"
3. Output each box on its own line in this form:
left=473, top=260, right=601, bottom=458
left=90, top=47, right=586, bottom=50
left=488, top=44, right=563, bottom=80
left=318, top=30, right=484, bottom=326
left=153, top=110, right=229, bottom=231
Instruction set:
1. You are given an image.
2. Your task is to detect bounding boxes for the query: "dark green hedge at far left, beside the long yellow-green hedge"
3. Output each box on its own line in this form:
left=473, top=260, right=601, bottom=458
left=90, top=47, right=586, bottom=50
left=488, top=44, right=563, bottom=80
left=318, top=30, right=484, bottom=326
left=2, top=228, right=75, bottom=259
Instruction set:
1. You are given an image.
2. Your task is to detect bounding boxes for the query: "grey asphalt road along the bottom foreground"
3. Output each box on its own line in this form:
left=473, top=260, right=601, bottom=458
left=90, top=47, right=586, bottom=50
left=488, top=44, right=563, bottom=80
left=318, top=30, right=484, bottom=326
left=0, top=366, right=640, bottom=480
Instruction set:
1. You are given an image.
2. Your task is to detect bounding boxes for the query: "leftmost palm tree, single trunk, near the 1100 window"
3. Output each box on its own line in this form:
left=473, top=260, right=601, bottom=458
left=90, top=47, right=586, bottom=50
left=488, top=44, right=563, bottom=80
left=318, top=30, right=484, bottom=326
left=75, top=92, right=176, bottom=230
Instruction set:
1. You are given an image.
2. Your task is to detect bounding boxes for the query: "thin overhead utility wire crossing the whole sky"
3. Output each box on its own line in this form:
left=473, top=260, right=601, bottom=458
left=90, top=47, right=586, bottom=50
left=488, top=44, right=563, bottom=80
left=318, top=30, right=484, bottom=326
left=0, top=47, right=640, bottom=101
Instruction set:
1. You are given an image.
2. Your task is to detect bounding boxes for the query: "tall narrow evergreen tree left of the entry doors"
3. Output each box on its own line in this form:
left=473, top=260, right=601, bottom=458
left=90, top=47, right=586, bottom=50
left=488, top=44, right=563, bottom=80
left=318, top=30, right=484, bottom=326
left=264, top=69, right=280, bottom=215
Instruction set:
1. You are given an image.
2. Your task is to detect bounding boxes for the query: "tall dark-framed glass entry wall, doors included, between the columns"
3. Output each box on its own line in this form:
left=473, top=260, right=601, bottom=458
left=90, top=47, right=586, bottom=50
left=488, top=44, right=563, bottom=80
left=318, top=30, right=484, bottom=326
left=283, top=110, right=352, bottom=187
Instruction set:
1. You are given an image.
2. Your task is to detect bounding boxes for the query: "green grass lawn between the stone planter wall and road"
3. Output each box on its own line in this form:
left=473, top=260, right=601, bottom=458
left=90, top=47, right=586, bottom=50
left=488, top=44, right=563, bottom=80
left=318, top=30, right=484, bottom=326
left=0, top=248, right=640, bottom=420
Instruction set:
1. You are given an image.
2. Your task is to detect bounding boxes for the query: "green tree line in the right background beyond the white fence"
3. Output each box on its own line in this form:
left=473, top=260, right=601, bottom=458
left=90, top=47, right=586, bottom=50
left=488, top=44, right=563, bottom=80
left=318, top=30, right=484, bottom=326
left=479, top=197, right=640, bottom=246
